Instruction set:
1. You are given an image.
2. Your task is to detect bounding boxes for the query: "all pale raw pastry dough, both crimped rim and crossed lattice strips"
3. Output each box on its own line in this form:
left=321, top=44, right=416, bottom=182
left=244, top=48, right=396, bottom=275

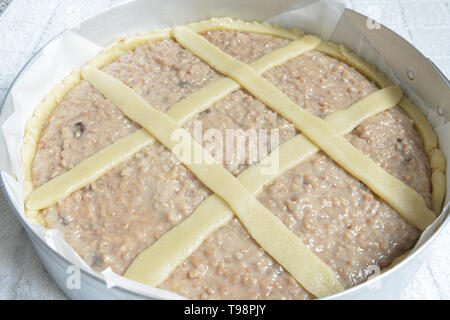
left=22, top=18, right=446, bottom=296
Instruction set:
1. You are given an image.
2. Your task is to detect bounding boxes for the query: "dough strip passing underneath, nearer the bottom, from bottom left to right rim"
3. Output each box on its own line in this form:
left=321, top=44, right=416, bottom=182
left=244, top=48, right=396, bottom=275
left=125, top=87, right=402, bottom=287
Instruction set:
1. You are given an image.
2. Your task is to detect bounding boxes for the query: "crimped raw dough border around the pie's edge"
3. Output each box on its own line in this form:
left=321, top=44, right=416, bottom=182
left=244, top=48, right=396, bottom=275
left=21, top=18, right=446, bottom=240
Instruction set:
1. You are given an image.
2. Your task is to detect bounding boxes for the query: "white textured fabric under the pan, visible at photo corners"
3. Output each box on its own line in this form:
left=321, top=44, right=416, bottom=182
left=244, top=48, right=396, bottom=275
left=0, top=0, right=450, bottom=299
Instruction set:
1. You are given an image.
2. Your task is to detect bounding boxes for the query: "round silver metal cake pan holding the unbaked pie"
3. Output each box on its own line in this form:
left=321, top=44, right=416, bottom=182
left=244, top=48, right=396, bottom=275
left=0, top=0, right=450, bottom=299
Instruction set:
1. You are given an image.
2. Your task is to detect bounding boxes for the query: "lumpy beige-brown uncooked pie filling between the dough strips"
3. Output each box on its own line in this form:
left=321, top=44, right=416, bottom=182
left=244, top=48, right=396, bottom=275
left=32, top=31, right=431, bottom=299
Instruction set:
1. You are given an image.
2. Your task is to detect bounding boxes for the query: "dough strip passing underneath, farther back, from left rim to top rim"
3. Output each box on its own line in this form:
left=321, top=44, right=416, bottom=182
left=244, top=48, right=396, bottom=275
left=26, top=36, right=321, bottom=211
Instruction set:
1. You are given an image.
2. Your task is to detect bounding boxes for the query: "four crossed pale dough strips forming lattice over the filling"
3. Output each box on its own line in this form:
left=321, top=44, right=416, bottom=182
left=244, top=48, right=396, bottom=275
left=22, top=18, right=444, bottom=297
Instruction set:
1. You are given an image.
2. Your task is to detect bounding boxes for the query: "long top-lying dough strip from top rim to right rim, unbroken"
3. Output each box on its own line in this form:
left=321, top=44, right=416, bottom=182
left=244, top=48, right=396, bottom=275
left=173, top=27, right=436, bottom=231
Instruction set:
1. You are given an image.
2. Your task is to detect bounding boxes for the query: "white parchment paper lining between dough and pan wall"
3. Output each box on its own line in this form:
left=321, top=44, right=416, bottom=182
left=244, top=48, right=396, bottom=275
left=1, top=1, right=450, bottom=299
